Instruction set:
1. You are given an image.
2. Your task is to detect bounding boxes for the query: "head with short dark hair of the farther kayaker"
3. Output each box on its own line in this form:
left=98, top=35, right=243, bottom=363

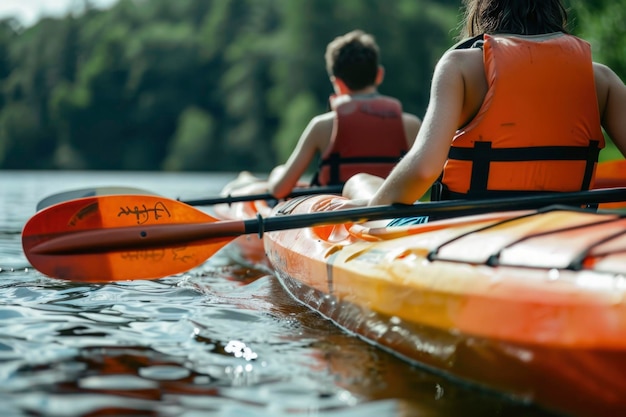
left=325, top=30, right=380, bottom=90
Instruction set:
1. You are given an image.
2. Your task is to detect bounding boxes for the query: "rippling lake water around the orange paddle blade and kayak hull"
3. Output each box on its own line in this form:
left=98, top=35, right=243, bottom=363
left=0, top=171, right=549, bottom=417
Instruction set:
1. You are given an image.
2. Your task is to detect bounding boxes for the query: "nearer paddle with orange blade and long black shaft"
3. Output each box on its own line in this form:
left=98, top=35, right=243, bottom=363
left=22, top=188, right=626, bottom=282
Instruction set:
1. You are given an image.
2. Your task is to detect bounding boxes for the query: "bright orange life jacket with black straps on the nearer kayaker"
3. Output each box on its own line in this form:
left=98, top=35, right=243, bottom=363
left=432, top=33, right=604, bottom=200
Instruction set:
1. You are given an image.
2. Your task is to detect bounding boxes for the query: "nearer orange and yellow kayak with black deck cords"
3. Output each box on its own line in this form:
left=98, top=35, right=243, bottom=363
left=263, top=195, right=626, bottom=417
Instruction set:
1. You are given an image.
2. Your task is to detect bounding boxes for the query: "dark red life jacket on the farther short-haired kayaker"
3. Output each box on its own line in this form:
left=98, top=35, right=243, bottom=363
left=311, top=95, right=408, bottom=185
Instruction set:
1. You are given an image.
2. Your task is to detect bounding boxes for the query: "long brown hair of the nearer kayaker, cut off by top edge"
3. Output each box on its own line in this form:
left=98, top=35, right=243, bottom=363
left=461, top=0, right=567, bottom=37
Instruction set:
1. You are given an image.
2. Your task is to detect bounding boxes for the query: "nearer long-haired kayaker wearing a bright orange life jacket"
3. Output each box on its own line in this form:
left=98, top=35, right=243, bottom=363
left=326, top=0, right=626, bottom=209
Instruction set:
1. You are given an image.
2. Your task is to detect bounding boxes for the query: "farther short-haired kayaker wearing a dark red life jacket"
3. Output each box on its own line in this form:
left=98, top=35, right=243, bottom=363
left=268, top=30, right=421, bottom=198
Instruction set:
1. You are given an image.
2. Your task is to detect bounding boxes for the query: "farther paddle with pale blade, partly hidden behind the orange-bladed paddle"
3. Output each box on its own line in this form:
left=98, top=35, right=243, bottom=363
left=37, top=185, right=342, bottom=211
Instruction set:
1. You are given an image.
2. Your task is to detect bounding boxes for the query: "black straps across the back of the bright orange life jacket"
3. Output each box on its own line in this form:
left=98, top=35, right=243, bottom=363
left=431, top=140, right=600, bottom=200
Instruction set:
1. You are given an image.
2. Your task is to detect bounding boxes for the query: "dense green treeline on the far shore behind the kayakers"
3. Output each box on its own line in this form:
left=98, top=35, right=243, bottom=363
left=0, top=0, right=626, bottom=171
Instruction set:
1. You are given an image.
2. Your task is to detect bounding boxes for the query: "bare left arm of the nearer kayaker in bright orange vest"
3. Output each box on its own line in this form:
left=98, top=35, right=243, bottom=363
left=369, top=51, right=464, bottom=205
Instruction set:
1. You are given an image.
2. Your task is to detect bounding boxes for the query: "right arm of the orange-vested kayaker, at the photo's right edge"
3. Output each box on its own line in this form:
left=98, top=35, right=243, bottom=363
left=594, top=63, right=626, bottom=157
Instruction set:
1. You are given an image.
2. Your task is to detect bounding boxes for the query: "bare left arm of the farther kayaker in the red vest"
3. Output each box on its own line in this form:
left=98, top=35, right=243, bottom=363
left=268, top=113, right=333, bottom=198
